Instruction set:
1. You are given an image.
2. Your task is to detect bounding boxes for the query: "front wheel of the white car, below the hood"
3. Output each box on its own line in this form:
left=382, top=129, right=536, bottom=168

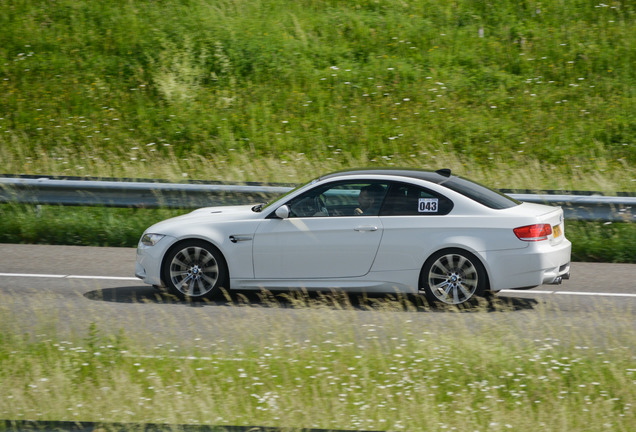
left=162, top=240, right=228, bottom=299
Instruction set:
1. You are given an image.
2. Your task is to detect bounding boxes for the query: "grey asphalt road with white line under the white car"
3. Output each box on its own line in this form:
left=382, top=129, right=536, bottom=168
left=0, top=244, right=636, bottom=346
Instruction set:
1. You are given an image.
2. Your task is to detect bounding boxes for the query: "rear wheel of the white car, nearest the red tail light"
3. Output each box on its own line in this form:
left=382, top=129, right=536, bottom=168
left=419, top=249, right=488, bottom=305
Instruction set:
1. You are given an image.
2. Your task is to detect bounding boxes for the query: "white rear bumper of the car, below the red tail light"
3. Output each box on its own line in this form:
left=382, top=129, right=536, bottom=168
left=485, top=239, right=572, bottom=291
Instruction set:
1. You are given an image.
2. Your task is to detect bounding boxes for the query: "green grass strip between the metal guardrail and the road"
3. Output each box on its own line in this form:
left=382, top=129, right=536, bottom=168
left=0, top=205, right=636, bottom=263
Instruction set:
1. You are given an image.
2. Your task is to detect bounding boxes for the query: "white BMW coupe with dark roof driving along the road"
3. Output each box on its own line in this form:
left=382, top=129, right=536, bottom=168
left=135, top=169, right=572, bottom=304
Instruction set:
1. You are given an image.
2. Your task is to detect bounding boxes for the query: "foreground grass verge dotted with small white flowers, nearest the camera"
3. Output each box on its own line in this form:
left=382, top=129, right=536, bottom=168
left=0, top=300, right=636, bottom=431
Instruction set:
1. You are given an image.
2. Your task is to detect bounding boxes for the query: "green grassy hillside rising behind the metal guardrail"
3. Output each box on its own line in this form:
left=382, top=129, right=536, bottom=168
left=0, top=0, right=636, bottom=192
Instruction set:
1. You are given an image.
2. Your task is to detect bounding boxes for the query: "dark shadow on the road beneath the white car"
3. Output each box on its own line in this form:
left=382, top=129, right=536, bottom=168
left=84, top=285, right=539, bottom=312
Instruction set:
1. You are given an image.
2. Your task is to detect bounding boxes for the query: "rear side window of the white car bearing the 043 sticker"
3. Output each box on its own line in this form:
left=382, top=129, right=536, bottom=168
left=380, top=183, right=453, bottom=216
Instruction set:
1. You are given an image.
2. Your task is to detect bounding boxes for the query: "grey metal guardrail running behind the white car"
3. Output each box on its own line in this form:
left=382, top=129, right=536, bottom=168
left=0, top=177, right=636, bottom=222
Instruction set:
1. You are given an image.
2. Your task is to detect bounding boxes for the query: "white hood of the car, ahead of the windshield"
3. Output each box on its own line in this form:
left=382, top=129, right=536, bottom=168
left=146, top=205, right=260, bottom=234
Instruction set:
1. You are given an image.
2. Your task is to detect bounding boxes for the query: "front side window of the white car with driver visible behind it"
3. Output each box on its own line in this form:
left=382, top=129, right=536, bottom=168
left=288, top=180, right=389, bottom=217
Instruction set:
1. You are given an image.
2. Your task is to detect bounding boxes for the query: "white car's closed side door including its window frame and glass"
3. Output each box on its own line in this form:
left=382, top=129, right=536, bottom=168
left=253, top=181, right=388, bottom=280
